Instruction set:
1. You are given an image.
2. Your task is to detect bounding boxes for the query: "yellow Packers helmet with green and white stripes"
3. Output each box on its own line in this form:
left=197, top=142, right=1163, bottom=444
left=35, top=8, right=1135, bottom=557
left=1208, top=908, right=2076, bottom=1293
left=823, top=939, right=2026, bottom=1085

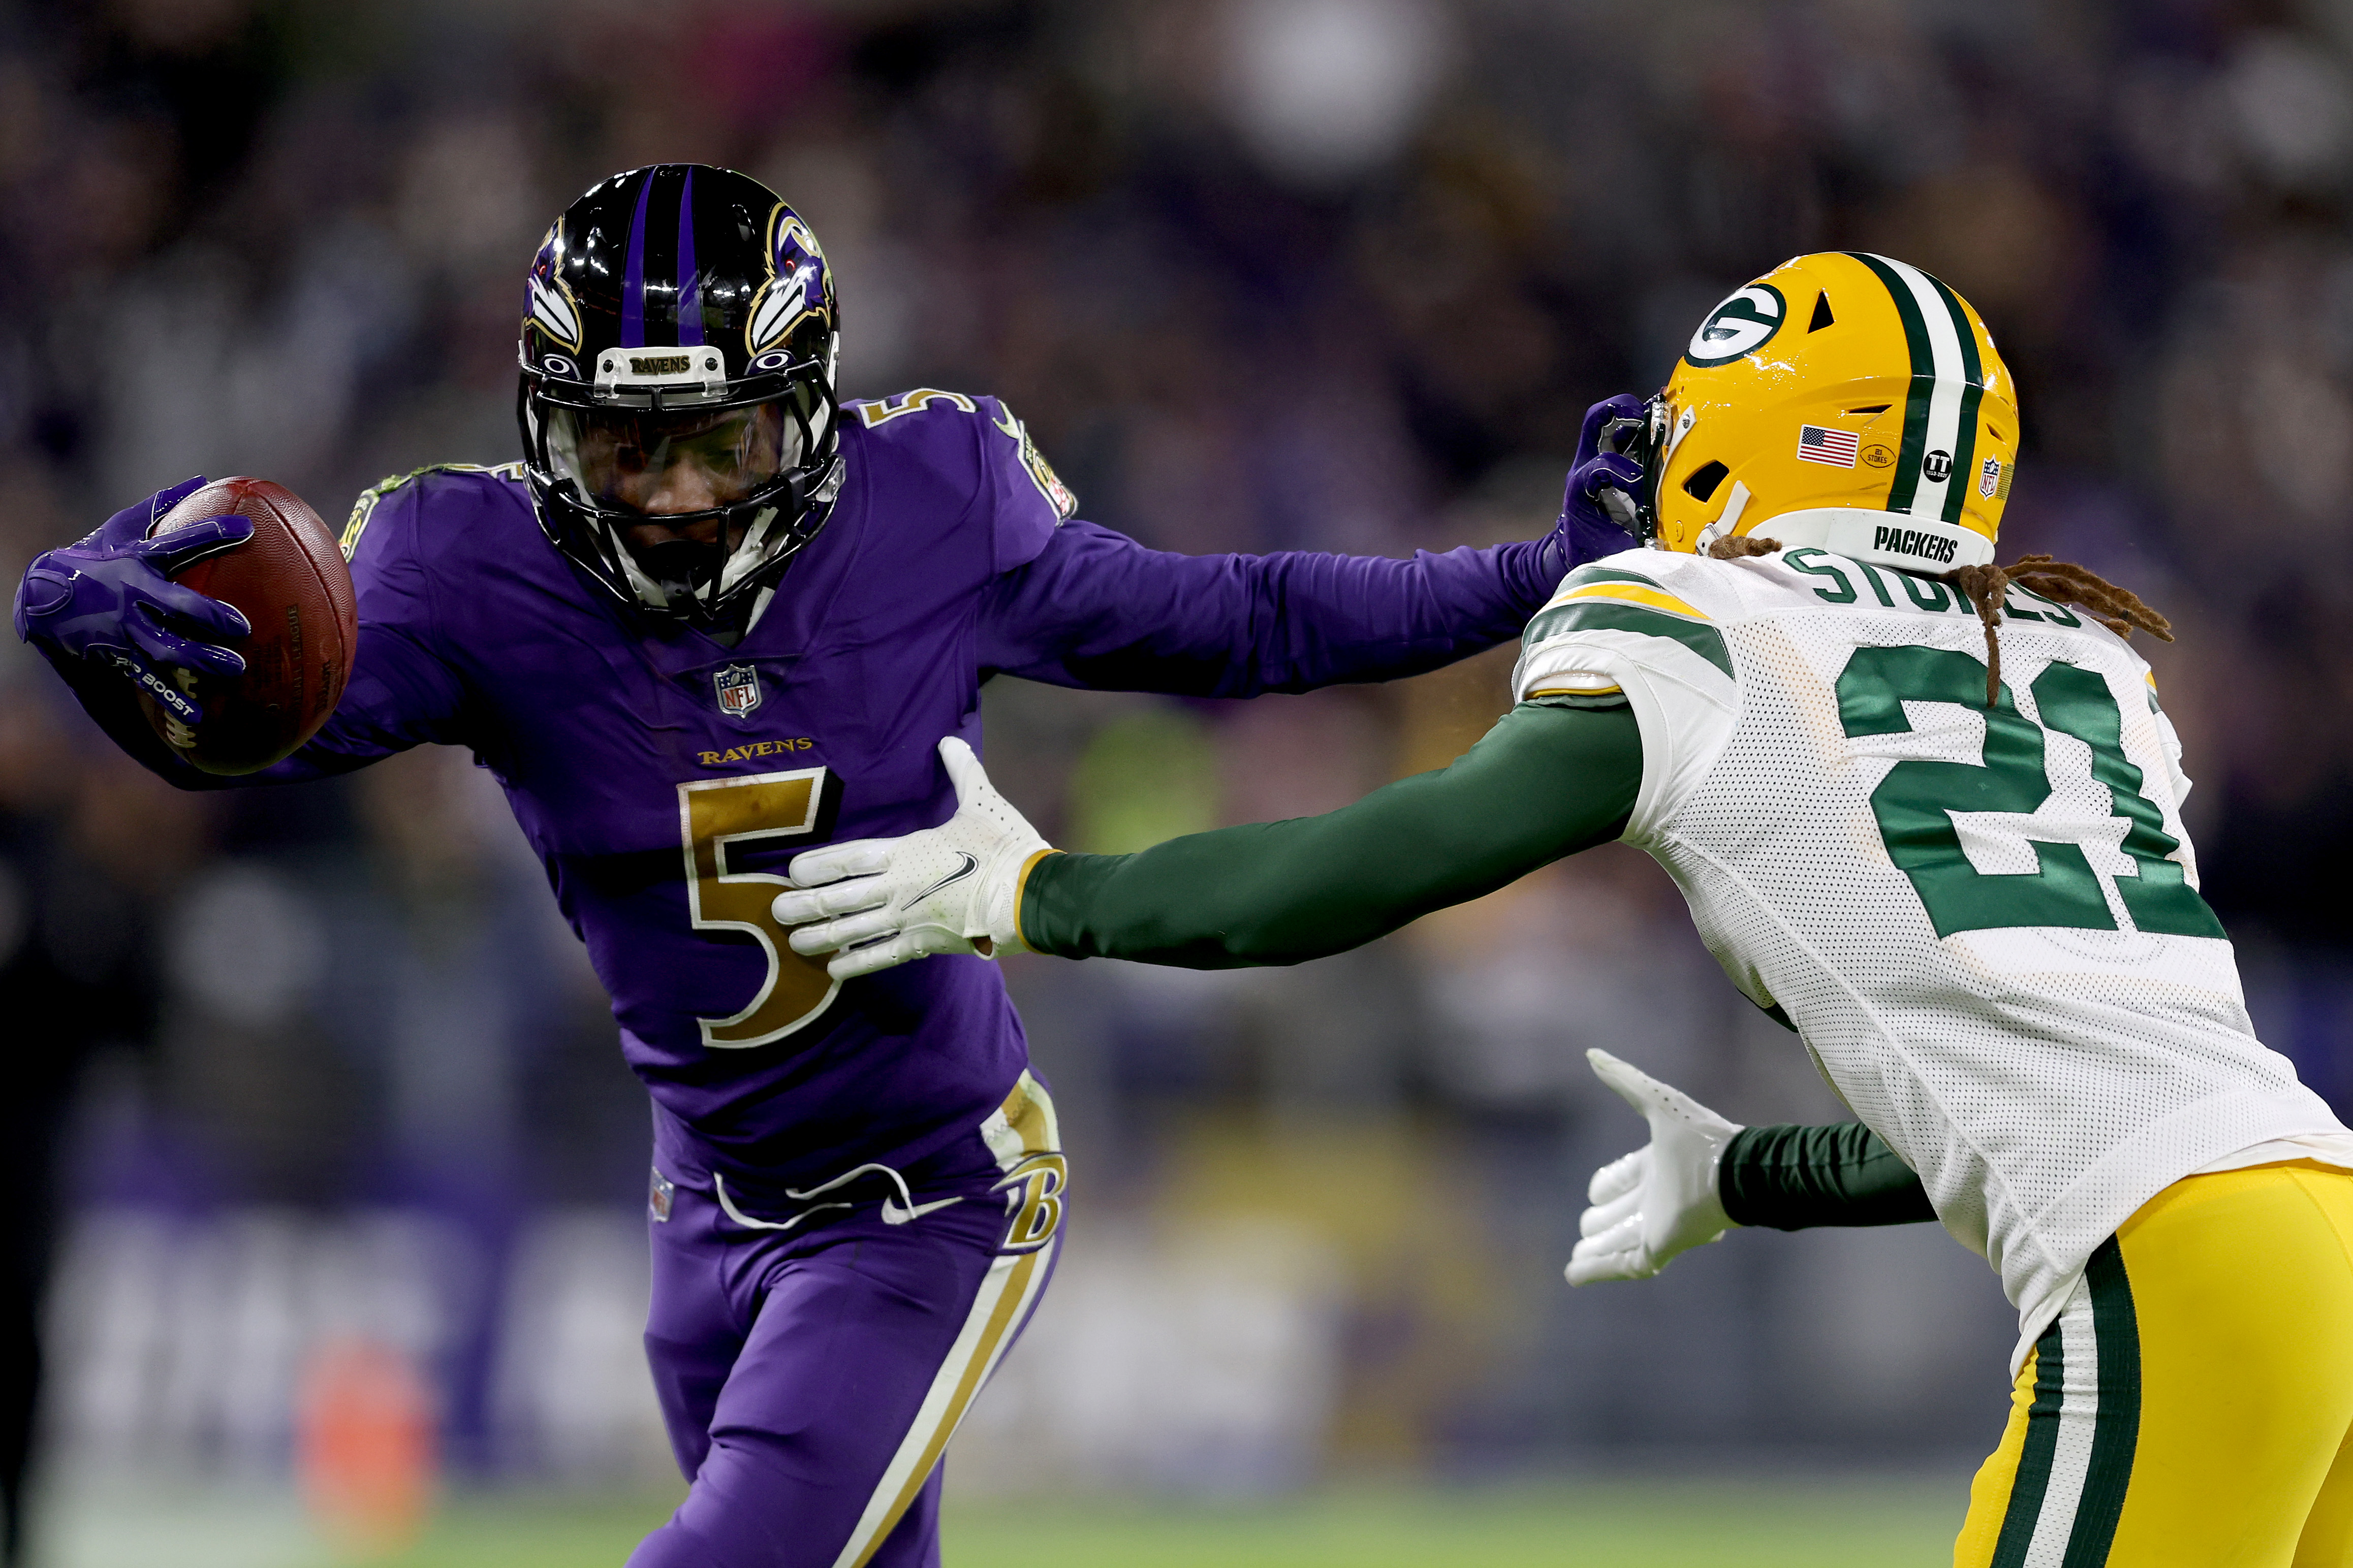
left=1605, top=251, right=2019, bottom=571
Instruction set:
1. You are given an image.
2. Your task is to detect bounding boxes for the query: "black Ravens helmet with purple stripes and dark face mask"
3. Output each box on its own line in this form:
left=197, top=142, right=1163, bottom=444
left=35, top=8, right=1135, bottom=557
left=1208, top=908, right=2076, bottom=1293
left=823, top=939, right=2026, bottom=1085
left=518, top=162, right=842, bottom=630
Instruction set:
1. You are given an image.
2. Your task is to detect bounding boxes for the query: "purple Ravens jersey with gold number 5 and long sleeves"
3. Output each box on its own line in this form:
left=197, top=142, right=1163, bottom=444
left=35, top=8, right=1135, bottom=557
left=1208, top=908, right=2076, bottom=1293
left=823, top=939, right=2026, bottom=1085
left=124, top=393, right=1553, bottom=1197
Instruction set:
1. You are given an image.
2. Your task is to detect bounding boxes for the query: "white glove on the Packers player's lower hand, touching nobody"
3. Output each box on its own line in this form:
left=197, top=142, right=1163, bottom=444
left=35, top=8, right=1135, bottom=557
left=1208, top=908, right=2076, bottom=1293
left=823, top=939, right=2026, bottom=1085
left=1567, top=1051, right=1741, bottom=1286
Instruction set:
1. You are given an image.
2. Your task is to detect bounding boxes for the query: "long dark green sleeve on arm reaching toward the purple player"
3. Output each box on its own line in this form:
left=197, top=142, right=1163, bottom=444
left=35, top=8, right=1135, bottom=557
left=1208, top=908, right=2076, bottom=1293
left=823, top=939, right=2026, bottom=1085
left=1021, top=703, right=1642, bottom=969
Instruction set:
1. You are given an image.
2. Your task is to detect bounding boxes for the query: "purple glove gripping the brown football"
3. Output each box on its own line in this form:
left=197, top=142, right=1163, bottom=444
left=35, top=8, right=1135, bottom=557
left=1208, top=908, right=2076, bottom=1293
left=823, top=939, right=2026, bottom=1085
left=16, top=475, right=254, bottom=724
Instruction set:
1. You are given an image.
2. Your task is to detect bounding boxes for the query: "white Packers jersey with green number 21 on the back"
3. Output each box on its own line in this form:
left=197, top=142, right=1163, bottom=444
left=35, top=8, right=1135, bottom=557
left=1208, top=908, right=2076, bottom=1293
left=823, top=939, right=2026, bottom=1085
left=1513, top=548, right=2346, bottom=1342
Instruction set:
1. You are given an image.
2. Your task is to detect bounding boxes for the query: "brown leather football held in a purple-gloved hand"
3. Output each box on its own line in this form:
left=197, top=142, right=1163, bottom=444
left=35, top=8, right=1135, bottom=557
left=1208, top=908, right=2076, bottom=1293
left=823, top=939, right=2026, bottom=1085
left=139, top=479, right=360, bottom=774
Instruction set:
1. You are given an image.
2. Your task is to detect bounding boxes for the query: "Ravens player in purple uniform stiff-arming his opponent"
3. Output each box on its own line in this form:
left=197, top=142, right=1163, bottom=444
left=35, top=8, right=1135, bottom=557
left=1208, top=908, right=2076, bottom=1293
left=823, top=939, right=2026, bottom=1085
left=16, top=165, right=1630, bottom=1568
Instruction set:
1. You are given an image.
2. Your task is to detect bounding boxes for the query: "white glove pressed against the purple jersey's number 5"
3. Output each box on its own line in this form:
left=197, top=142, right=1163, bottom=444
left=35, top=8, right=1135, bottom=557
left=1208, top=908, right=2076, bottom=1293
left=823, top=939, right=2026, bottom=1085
left=772, top=738, right=1049, bottom=980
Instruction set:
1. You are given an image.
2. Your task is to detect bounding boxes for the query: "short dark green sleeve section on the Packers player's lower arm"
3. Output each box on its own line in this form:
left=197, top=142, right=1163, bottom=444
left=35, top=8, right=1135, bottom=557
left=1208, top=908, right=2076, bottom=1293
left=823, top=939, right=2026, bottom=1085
left=1715, top=1122, right=1936, bottom=1230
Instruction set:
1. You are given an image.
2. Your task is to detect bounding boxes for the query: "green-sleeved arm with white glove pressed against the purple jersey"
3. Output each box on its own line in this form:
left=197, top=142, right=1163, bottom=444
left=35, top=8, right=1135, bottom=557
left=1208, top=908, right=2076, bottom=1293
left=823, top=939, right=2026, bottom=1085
left=776, top=705, right=1642, bottom=980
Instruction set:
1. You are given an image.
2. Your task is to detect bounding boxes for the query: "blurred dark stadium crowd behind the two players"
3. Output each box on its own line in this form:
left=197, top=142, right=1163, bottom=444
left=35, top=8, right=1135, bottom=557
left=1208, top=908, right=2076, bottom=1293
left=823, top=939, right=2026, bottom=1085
left=0, top=0, right=2353, bottom=1561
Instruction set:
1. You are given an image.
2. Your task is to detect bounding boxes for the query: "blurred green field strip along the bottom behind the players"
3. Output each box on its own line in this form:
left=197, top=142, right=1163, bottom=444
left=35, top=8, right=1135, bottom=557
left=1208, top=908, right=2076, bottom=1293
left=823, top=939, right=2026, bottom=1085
left=35, top=1479, right=1965, bottom=1568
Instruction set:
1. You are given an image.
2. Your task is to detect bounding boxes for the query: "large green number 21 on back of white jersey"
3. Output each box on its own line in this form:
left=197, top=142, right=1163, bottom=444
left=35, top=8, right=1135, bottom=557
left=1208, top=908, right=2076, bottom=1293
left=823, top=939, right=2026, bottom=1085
left=1838, top=647, right=2223, bottom=938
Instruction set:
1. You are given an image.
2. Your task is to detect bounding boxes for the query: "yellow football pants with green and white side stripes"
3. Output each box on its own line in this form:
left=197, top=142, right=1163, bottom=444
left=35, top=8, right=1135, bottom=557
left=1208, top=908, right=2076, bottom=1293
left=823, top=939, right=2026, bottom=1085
left=1953, top=1161, right=2353, bottom=1568
